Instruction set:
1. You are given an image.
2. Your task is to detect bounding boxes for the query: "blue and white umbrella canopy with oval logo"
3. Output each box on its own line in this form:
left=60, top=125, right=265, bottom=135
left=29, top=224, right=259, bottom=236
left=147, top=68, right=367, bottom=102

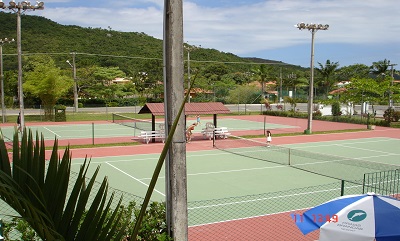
left=295, top=193, right=400, bottom=241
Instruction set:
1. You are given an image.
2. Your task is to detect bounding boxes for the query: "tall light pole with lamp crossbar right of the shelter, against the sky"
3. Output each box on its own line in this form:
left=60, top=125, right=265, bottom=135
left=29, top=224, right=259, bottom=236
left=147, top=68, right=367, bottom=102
left=294, top=23, right=329, bottom=134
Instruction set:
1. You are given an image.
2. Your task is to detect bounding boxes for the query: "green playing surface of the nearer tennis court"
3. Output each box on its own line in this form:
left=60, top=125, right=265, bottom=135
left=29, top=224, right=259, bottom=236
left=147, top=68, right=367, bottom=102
left=72, top=138, right=400, bottom=225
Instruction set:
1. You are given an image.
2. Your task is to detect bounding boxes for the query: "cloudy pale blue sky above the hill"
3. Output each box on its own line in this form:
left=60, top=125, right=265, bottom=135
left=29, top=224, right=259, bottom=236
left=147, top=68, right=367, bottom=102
left=22, top=0, right=400, bottom=69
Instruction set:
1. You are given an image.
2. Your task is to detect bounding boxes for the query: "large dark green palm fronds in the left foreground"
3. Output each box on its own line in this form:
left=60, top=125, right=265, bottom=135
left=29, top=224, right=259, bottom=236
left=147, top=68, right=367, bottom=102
left=0, top=129, right=128, bottom=240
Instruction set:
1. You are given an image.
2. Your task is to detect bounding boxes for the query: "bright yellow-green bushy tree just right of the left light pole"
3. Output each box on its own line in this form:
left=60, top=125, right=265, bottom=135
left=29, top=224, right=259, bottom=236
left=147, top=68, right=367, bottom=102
left=23, top=55, right=73, bottom=120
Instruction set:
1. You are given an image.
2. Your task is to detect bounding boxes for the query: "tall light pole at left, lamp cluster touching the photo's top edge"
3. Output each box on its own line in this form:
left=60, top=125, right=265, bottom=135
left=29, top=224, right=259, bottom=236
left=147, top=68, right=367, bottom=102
left=0, top=0, right=44, bottom=130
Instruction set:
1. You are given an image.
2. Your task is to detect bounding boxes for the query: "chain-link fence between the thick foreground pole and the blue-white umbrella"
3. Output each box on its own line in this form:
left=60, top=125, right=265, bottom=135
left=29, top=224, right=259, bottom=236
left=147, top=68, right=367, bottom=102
left=188, top=180, right=400, bottom=241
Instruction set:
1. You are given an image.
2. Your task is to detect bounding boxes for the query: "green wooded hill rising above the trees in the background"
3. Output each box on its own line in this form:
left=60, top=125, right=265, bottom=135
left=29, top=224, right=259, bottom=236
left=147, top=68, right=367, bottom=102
left=0, top=12, right=296, bottom=73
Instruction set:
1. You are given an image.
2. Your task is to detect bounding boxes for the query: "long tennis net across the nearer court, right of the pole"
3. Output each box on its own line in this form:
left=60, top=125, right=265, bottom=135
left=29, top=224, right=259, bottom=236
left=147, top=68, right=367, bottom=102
left=214, top=136, right=400, bottom=183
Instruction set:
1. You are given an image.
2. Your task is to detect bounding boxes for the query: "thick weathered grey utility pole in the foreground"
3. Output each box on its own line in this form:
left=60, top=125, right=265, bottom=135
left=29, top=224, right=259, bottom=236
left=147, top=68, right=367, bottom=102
left=164, top=0, right=188, bottom=241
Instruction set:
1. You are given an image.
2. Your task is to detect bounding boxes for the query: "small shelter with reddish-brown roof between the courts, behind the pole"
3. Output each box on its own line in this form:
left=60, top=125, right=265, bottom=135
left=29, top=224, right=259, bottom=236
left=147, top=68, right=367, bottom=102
left=138, top=102, right=231, bottom=130
